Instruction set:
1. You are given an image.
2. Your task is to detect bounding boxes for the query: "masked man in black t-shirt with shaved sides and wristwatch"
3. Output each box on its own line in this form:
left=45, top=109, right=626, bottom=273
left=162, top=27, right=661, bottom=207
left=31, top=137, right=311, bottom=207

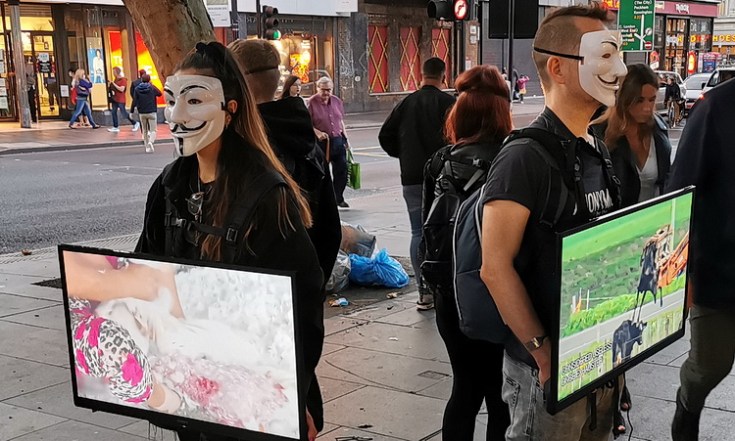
left=482, top=6, right=626, bottom=441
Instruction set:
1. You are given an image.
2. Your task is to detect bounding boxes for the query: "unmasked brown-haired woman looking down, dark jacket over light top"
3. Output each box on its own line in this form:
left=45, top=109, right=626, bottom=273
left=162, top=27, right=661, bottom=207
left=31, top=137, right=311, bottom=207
left=594, top=64, right=678, bottom=207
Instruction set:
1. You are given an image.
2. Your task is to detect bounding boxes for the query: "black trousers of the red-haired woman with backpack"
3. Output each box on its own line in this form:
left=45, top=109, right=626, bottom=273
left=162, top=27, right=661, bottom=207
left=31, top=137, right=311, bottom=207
left=434, top=288, right=510, bottom=441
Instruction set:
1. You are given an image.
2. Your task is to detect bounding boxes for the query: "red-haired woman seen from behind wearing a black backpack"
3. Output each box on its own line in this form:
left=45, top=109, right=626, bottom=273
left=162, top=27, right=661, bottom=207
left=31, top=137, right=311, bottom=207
left=421, top=65, right=513, bottom=441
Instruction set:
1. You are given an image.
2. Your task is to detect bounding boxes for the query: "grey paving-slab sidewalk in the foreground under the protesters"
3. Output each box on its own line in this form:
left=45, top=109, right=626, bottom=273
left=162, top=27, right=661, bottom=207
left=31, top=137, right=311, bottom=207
left=0, top=184, right=735, bottom=441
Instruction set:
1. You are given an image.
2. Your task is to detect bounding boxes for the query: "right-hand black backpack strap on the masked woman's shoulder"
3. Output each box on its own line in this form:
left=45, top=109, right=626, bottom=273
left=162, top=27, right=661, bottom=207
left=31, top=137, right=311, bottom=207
left=222, top=171, right=286, bottom=263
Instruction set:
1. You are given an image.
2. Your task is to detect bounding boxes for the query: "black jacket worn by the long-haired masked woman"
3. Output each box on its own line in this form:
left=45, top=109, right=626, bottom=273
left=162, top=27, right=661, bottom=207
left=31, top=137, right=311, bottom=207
left=136, top=141, right=324, bottom=434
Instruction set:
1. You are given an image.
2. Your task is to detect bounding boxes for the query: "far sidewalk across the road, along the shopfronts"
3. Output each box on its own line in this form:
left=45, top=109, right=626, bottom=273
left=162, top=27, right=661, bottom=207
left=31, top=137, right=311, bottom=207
left=0, top=98, right=543, bottom=155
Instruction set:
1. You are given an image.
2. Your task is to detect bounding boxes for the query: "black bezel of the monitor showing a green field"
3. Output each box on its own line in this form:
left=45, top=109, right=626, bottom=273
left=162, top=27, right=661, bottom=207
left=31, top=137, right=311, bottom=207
left=546, top=186, right=696, bottom=415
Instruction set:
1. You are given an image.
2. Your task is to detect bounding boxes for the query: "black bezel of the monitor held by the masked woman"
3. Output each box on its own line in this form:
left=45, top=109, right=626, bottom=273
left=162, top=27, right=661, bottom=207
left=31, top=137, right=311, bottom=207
left=58, top=244, right=308, bottom=441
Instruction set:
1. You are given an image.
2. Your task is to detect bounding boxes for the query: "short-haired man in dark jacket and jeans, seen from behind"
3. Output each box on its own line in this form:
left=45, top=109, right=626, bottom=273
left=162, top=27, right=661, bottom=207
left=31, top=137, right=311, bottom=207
left=378, top=57, right=455, bottom=310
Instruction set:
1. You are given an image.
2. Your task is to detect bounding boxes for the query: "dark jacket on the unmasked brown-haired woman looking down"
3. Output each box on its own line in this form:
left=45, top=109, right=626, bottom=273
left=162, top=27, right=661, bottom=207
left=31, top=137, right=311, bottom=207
left=593, top=116, right=671, bottom=207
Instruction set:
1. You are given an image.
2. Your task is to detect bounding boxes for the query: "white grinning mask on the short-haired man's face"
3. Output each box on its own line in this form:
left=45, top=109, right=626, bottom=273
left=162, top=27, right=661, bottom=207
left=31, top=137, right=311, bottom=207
left=579, top=30, right=628, bottom=107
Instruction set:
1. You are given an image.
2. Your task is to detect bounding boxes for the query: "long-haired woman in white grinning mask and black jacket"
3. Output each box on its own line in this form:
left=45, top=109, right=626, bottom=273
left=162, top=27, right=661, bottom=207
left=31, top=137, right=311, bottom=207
left=136, top=42, right=324, bottom=441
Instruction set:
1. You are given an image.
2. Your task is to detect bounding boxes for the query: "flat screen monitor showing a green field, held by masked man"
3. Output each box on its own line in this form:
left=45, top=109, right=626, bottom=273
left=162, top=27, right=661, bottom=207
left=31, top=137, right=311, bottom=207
left=547, top=187, right=694, bottom=413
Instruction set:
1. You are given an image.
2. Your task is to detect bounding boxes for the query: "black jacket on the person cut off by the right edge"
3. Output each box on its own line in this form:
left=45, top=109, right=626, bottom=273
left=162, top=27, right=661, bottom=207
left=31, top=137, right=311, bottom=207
left=666, top=80, right=735, bottom=308
